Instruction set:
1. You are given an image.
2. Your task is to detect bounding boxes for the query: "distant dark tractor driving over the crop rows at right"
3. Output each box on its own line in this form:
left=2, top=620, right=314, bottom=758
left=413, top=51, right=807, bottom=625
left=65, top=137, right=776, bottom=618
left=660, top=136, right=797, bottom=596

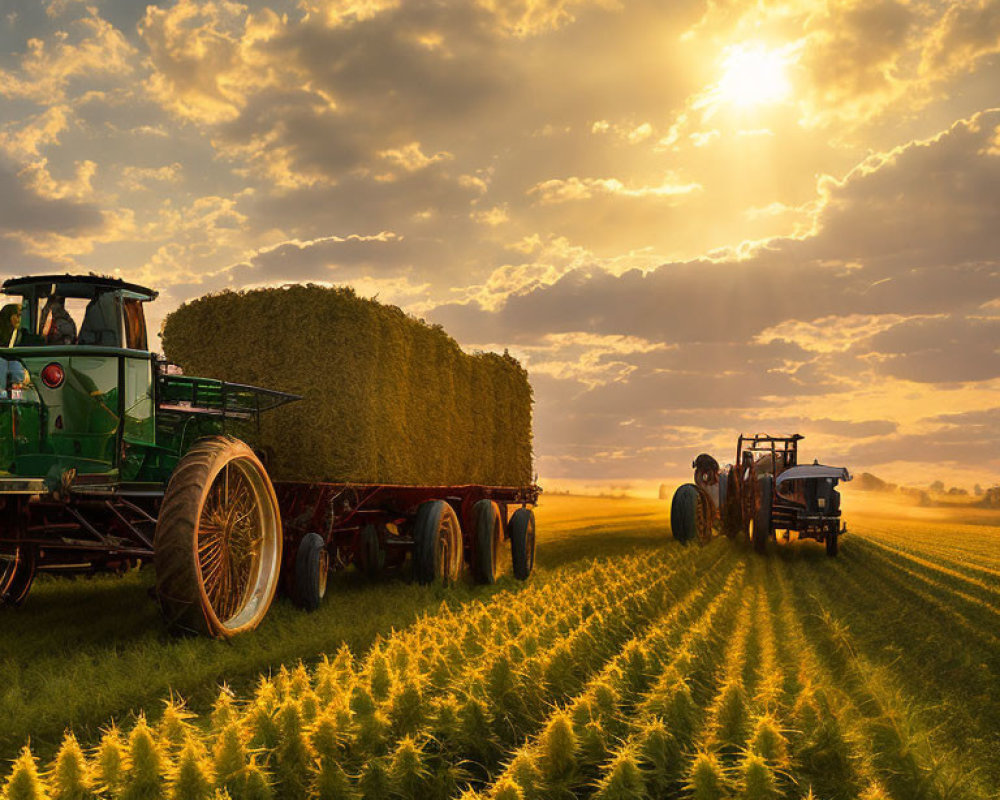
left=670, top=434, right=851, bottom=556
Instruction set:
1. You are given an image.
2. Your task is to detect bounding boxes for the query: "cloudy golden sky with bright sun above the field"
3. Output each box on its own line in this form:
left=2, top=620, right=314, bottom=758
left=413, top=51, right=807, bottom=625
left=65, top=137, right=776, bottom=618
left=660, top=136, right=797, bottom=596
left=0, top=0, right=1000, bottom=488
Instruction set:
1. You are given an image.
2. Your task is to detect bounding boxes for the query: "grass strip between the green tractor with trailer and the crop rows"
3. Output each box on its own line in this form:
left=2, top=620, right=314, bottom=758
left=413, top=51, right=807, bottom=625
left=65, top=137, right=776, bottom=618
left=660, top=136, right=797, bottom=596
left=0, top=496, right=669, bottom=759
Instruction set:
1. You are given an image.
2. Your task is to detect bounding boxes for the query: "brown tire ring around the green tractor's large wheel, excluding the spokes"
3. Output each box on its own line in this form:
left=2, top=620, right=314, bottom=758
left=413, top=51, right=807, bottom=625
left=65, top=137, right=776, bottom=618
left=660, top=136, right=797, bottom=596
left=153, top=436, right=282, bottom=639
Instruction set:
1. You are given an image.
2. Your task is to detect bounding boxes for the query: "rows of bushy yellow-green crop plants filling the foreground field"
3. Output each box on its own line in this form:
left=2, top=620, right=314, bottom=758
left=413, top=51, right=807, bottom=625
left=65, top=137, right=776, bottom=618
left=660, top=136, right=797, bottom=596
left=7, top=498, right=1000, bottom=800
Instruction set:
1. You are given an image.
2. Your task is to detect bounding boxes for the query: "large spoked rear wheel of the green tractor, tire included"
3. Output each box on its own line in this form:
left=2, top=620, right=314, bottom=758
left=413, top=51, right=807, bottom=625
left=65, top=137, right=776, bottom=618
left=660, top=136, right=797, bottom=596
left=153, top=436, right=282, bottom=638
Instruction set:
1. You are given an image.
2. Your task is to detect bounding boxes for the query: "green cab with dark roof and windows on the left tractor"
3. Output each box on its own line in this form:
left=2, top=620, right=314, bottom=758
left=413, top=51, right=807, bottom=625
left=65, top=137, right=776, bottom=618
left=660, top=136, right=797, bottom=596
left=0, top=275, right=156, bottom=492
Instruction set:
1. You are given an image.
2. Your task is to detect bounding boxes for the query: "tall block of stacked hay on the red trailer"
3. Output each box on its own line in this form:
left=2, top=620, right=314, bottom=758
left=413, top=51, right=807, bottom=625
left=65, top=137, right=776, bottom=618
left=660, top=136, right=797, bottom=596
left=163, top=285, right=532, bottom=486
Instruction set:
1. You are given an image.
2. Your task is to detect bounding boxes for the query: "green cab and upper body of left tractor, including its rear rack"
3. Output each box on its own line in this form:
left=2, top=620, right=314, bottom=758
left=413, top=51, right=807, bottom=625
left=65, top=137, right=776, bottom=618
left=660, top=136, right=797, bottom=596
left=0, top=275, right=299, bottom=497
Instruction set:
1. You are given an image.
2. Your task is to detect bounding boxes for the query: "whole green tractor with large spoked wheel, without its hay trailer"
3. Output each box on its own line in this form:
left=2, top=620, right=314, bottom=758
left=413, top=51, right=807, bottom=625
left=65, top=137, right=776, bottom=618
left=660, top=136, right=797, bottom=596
left=0, top=275, right=296, bottom=637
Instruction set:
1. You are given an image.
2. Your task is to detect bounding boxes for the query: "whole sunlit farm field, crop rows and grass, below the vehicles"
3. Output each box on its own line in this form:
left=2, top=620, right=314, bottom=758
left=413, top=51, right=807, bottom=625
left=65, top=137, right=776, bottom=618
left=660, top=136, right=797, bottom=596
left=0, top=493, right=1000, bottom=800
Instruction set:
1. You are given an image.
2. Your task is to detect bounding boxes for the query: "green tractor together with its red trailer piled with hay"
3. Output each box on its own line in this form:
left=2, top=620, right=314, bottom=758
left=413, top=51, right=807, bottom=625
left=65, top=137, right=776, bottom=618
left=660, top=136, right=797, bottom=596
left=0, top=275, right=540, bottom=638
